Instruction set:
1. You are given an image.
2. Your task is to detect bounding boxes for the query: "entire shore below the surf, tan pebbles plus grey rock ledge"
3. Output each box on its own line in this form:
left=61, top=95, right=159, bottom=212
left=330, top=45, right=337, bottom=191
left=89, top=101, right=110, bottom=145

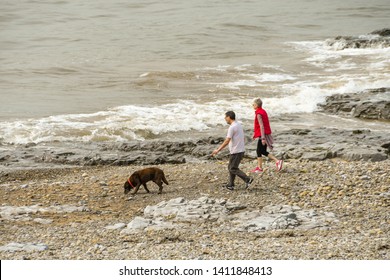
left=0, top=92, right=390, bottom=260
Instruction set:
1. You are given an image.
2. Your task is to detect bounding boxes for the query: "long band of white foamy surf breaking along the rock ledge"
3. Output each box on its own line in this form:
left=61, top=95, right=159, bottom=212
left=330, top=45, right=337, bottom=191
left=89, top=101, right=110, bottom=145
left=0, top=79, right=390, bottom=144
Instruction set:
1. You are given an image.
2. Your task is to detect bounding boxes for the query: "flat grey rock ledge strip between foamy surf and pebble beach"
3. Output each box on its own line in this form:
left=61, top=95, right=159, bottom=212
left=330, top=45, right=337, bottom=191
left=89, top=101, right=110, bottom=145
left=0, top=120, right=390, bottom=174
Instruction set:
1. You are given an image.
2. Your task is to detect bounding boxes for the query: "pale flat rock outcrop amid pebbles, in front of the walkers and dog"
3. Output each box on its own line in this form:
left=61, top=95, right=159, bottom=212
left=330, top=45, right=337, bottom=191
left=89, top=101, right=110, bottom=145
left=121, top=196, right=337, bottom=234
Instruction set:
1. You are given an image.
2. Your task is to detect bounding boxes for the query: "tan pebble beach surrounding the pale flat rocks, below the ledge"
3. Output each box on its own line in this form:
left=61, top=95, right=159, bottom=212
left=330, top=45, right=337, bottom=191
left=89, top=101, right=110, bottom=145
left=0, top=159, right=390, bottom=260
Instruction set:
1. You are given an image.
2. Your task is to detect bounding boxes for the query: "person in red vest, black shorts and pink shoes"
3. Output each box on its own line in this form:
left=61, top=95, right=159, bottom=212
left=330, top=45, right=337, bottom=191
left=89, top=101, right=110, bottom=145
left=251, top=98, right=283, bottom=173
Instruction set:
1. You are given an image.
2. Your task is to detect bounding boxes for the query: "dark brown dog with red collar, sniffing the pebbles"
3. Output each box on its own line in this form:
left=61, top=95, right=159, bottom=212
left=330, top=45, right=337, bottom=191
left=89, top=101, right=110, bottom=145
left=124, top=167, right=169, bottom=194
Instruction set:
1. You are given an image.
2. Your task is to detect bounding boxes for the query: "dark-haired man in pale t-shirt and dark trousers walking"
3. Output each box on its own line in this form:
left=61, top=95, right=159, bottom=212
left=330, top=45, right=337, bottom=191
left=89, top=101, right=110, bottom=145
left=211, top=111, right=253, bottom=190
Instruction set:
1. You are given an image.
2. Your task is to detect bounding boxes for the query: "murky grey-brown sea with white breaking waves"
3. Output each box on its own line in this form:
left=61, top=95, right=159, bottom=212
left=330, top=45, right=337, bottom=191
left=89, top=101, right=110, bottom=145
left=0, top=0, right=390, bottom=149
